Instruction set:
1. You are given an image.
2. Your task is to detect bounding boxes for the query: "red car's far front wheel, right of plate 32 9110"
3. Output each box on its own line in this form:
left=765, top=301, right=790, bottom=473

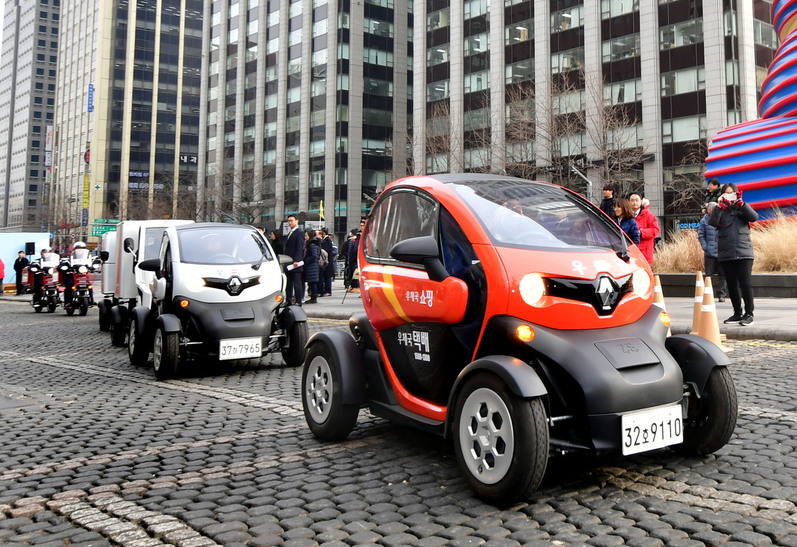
left=671, top=367, right=738, bottom=456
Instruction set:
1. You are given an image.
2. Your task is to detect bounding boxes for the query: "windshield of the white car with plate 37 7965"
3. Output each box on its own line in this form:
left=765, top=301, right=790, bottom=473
left=177, top=226, right=273, bottom=264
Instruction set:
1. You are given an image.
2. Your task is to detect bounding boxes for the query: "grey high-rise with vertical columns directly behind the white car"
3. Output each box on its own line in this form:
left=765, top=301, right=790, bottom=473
left=199, top=0, right=413, bottom=233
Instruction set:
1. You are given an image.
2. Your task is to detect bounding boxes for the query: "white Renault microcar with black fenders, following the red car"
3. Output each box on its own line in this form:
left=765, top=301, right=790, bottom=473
left=134, top=223, right=307, bottom=379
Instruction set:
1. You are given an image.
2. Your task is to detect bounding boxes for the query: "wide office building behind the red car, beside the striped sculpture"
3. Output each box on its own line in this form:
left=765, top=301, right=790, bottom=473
left=412, top=0, right=777, bottom=226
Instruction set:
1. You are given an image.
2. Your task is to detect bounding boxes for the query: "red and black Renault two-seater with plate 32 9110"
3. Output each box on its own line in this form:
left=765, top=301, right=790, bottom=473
left=302, top=174, right=737, bottom=504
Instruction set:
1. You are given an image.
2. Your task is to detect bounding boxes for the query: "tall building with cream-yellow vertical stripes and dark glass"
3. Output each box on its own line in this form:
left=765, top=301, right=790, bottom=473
left=52, top=0, right=204, bottom=244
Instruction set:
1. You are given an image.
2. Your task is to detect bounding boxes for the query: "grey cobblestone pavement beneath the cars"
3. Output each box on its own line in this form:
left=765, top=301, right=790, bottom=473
left=0, top=302, right=797, bottom=547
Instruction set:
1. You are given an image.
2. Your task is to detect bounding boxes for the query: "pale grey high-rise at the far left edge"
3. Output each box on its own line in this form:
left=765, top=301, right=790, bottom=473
left=0, top=0, right=61, bottom=232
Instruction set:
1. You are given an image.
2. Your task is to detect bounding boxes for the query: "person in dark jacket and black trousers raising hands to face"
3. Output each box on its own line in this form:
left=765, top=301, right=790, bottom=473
left=708, top=182, right=758, bottom=325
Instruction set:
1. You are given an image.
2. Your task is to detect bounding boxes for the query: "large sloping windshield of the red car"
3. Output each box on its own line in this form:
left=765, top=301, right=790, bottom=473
left=450, top=179, right=622, bottom=251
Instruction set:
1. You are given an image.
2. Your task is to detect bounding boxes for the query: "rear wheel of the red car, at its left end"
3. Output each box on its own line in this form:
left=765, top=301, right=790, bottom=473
left=302, top=341, right=360, bottom=441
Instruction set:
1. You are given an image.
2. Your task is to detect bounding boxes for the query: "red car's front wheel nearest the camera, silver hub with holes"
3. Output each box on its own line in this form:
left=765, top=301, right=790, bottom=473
left=453, top=373, right=549, bottom=506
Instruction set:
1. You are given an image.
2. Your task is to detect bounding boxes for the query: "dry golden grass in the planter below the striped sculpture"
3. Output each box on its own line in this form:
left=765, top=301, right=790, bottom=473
left=653, top=218, right=797, bottom=273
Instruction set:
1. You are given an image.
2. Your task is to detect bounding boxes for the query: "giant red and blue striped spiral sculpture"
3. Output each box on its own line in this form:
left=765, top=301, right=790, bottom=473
left=706, top=0, right=797, bottom=220
